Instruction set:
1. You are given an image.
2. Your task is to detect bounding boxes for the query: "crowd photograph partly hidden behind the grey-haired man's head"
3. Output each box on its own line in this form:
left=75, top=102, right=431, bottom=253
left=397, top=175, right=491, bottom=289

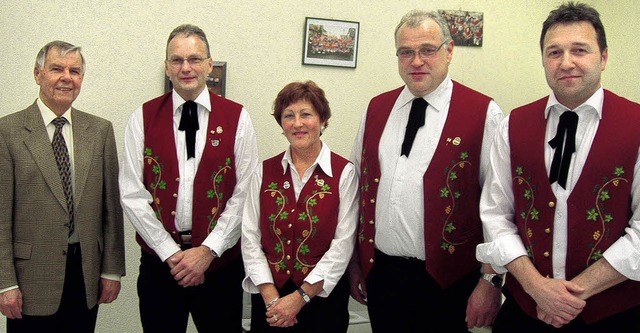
left=438, top=9, right=484, bottom=46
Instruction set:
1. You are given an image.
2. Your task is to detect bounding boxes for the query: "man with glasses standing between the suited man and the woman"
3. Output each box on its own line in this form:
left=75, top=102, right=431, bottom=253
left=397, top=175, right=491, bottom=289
left=120, top=24, right=258, bottom=332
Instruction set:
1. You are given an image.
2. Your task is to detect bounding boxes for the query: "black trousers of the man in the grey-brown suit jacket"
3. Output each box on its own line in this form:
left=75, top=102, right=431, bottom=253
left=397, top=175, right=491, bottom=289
left=7, top=244, right=98, bottom=333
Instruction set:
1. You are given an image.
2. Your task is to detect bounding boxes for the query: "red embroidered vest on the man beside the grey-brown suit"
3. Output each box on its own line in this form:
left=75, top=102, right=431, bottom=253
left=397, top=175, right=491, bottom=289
left=136, top=92, right=242, bottom=269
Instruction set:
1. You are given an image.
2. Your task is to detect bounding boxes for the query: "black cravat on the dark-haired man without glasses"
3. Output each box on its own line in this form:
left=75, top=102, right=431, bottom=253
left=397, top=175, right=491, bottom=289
left=549, top=111, right=578, bottom=189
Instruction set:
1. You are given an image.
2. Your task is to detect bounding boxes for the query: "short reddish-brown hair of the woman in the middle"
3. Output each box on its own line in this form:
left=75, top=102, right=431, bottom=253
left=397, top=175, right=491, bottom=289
left=273, top=80, right=331, bottom=128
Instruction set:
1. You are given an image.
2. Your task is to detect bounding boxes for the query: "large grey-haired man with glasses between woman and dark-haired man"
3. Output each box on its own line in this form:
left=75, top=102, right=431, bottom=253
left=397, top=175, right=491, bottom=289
left=349, top=11, right=503, bottom=332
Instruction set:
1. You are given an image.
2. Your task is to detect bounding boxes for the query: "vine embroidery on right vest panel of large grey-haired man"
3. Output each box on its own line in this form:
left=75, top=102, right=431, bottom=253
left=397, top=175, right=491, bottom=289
left=440, top=151, right=471, bottom=254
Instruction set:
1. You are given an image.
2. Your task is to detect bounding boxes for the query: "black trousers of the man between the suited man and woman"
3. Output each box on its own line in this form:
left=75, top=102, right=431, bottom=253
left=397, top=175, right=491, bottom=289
left=138, top=250, right=244, bottom=333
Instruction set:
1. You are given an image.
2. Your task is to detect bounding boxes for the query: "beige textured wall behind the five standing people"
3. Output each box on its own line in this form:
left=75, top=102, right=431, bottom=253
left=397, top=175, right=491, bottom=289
left=0, top=0, right=640, bottom=332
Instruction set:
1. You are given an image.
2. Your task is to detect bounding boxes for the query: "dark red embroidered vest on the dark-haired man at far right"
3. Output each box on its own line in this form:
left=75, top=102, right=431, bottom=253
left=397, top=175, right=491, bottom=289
left=507, top=90, right=640, bottom=323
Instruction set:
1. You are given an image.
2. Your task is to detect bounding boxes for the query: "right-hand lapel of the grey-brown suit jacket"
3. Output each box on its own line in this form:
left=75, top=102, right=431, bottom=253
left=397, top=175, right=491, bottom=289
left=71, top=108, right=95, bottom=208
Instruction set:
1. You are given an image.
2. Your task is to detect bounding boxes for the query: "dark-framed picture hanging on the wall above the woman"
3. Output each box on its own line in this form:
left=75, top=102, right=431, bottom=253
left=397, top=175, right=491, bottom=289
left=302, top=17, right=360, bottom=68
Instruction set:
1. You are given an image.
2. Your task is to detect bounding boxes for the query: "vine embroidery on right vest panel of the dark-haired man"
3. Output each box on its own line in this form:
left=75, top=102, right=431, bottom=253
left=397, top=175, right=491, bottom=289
left=586, top=167, right=629, bottom=266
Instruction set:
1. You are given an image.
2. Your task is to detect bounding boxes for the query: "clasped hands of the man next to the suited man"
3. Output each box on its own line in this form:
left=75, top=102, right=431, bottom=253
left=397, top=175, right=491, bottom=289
left=167, top=245, right=213, bottom=287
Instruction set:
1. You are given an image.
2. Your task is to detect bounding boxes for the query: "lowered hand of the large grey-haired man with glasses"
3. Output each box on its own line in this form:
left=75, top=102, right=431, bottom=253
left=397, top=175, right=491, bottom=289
left=466, top=280, right=502, bottom=329
